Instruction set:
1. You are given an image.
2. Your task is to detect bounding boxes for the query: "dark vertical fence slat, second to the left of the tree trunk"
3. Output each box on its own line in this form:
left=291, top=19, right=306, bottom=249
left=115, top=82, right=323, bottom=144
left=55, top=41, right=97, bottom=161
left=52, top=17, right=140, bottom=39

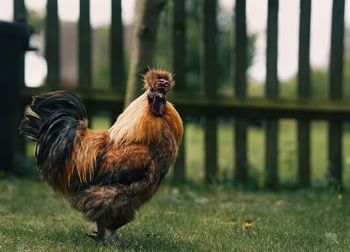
left=78, top=0, right=92, bottom=88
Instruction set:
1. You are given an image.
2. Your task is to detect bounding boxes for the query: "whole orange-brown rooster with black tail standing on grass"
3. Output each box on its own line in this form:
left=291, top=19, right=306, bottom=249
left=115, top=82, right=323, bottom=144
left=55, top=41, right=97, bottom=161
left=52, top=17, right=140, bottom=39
left=19, top=70, right=183, bottom=245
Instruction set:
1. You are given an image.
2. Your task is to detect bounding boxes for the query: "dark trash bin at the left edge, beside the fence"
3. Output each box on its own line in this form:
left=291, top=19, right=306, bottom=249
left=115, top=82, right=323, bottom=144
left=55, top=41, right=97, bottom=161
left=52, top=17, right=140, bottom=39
left=0, top=21, right=32, bottom=171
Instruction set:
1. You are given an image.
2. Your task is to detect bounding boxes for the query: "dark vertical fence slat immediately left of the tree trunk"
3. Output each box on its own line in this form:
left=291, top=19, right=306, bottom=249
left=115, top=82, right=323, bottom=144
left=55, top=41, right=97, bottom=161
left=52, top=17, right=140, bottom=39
left=110, top=0, right=125, bottom=94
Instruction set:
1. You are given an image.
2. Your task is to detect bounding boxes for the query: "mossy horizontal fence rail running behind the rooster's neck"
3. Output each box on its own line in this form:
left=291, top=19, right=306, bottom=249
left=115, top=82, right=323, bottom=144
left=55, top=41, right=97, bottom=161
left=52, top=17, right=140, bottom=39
left=21, top=86, right=350, bottom=121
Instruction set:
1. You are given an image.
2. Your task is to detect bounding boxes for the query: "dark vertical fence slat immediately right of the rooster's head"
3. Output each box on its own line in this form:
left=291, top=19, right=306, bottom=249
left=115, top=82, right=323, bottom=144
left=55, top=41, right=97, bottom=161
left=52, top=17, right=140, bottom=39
left=172, top=0, right=186, bottom=181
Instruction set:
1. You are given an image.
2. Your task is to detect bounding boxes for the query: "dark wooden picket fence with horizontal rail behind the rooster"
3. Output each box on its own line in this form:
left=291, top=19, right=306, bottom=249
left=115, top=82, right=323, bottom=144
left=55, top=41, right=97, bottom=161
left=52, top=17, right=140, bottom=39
left=14, top=0, right=350, bottom=188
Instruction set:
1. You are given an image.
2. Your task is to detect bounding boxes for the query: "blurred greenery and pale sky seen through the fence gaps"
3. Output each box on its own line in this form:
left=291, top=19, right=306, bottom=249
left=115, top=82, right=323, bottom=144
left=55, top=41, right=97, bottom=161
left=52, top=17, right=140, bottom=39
left=0, top=0, right=350, bottom=187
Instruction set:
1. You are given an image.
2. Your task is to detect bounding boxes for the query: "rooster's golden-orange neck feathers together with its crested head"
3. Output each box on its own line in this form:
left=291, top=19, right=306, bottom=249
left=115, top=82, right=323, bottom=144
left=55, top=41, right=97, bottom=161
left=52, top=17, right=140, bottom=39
left=109, top=70, right=183, bottom=145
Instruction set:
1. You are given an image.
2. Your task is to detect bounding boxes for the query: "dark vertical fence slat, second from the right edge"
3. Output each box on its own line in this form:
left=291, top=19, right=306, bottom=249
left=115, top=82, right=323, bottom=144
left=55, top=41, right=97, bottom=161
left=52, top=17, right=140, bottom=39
left=298, top=0, right=311, bottom=187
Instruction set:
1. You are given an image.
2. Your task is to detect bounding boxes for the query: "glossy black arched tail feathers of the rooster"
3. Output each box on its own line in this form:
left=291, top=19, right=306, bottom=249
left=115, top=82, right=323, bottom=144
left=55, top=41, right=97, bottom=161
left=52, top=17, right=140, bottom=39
left=19, top=91, right=87, bottom=173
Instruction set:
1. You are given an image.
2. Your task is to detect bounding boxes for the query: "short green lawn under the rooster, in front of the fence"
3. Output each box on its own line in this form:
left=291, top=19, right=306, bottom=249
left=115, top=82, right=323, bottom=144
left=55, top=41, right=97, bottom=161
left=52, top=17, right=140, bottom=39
left=0, top=177, right=350, bottom=251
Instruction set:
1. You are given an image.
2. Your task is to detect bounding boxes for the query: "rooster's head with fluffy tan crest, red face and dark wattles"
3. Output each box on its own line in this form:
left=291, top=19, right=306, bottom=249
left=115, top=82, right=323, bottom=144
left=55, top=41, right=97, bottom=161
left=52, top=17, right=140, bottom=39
left=144, top=70, right=173, bottom=116
